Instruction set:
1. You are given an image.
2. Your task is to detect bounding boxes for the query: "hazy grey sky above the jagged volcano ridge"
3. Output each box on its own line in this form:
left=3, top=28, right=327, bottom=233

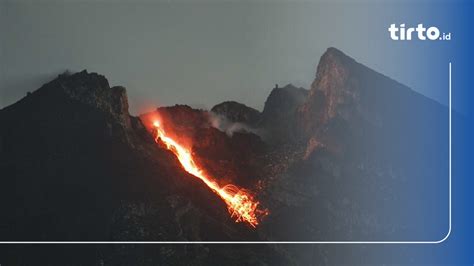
left=0, top=0, right=447, bottom=114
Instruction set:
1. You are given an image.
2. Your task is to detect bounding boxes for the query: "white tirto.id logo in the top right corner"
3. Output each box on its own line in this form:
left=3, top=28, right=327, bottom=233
left=388, top=24, right=451, bottom=41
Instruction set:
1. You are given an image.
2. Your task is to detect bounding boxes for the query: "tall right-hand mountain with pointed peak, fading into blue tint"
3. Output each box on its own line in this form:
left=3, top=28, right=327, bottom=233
left=263, top=48, right=448, bottom=240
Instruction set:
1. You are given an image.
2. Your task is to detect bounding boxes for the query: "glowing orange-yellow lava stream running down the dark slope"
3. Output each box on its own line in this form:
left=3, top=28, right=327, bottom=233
left=153, top=122, right=268, bottom=228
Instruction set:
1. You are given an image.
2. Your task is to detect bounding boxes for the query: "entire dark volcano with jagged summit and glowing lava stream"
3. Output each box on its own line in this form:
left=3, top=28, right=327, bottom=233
left=0, top=48, right=448, bottom=265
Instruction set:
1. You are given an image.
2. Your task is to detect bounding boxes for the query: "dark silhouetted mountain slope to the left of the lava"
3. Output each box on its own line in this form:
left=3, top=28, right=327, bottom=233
left=0, top=71, right=281, bottom=264
